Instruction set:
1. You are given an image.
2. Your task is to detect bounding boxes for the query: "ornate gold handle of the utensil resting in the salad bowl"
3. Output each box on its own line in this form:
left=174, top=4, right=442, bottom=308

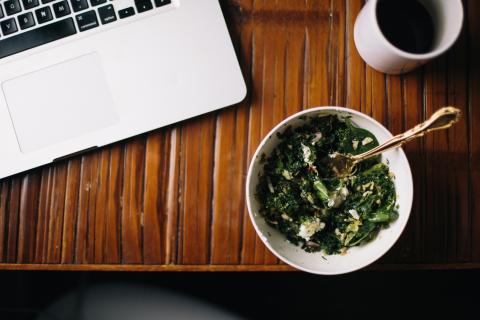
left=352, top=107, right=461, bottom=162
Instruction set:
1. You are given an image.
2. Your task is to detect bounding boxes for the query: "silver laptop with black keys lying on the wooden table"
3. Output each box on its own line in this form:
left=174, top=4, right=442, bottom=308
left=0, top=0, right=246, bottom=178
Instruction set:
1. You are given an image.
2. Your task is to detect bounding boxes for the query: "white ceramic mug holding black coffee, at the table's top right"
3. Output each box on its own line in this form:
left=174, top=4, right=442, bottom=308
left=354, top=0, right=463, bottom=74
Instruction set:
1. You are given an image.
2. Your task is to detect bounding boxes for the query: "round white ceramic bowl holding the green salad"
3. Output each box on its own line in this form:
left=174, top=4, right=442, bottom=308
left=246, top=107, right=413, bottom=275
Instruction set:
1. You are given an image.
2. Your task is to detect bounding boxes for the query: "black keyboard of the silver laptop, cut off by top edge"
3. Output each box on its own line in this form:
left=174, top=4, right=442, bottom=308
left=0, top=0, right=171, bottom=59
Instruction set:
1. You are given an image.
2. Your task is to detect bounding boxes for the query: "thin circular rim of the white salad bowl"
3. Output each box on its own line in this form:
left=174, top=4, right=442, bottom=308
left=245, top=106, right=414, bottom=275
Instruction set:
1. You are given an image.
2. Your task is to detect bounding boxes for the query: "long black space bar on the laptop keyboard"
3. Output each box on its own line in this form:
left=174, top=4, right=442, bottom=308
left=0, top=18, right=77, bottom=59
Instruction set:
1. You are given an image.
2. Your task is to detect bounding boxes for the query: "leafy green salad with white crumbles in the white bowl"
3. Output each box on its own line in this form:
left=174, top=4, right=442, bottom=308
left=256, top=115, right=398, bottom=254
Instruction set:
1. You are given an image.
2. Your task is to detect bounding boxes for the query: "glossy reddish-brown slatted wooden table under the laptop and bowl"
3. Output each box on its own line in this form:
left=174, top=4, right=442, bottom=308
left=0, top=0, right=480, bottom=270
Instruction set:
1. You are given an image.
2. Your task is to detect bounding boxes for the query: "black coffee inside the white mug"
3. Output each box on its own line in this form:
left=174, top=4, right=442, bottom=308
left=377, top=0, right=435, bottom=53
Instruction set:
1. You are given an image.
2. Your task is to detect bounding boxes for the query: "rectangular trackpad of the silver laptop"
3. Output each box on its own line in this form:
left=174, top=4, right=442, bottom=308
left=2, top=53, right=118, bottom=153
